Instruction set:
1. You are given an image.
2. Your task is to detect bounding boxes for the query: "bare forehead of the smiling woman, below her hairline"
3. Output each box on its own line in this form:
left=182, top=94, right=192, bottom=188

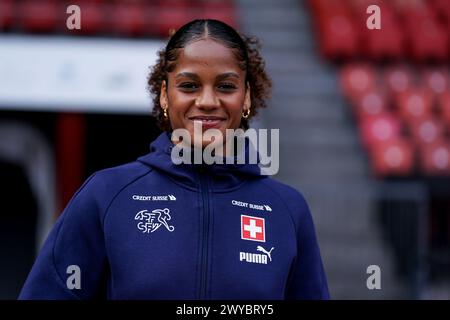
left=175, top=39, right=242, bottom=73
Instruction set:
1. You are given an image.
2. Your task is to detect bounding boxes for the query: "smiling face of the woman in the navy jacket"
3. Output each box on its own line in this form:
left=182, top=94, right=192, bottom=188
left=160, top=39, right=250, bottom=146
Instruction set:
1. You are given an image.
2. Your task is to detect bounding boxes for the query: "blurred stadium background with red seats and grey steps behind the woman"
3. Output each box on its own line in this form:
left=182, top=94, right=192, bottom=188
left=0, top=0, right=450, bottom=299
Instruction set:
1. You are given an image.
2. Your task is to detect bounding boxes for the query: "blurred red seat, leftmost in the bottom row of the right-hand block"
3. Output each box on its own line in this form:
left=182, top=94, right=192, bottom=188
left=369, top=139, right=414, bottom=177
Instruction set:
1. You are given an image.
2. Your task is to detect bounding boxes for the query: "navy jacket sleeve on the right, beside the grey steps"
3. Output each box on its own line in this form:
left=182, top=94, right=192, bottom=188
left=286, top=195, right=330, bottom=300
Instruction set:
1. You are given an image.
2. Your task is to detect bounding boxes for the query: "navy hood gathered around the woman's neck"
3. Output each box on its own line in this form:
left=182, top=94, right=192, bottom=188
left=138, top=132, right=267, bottom=191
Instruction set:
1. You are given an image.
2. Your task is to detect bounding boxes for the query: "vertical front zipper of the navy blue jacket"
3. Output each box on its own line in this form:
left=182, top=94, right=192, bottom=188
left=199, top=168, right=210, bottom=300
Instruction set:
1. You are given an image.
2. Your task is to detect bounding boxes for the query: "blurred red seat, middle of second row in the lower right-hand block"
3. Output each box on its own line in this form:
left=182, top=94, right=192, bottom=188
left=396, top=89, right=433, bottom=122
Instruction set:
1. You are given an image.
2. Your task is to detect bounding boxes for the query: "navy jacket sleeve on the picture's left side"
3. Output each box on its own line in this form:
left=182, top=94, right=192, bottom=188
left=19, top=176, right=107, bottom=300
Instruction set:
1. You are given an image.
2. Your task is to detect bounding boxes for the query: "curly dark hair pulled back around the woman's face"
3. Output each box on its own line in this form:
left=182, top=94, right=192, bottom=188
left=147, top=19, right=272, bottom=131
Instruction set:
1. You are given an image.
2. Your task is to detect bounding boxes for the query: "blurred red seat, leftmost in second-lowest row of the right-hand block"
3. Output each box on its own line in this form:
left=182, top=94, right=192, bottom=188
left=359, top=112, right=401, bottom=146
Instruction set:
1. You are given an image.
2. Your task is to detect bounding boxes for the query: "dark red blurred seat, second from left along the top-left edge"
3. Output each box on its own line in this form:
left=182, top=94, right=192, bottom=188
left=17, top=0, right=59, bottom=33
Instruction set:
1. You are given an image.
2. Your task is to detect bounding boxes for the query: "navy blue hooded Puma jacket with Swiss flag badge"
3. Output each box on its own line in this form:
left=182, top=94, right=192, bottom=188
left=19, top=133, right=329, bottom=300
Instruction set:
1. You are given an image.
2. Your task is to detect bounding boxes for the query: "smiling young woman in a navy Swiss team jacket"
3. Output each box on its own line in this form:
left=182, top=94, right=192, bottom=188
left=20, top=20, right=329, bottom=299
